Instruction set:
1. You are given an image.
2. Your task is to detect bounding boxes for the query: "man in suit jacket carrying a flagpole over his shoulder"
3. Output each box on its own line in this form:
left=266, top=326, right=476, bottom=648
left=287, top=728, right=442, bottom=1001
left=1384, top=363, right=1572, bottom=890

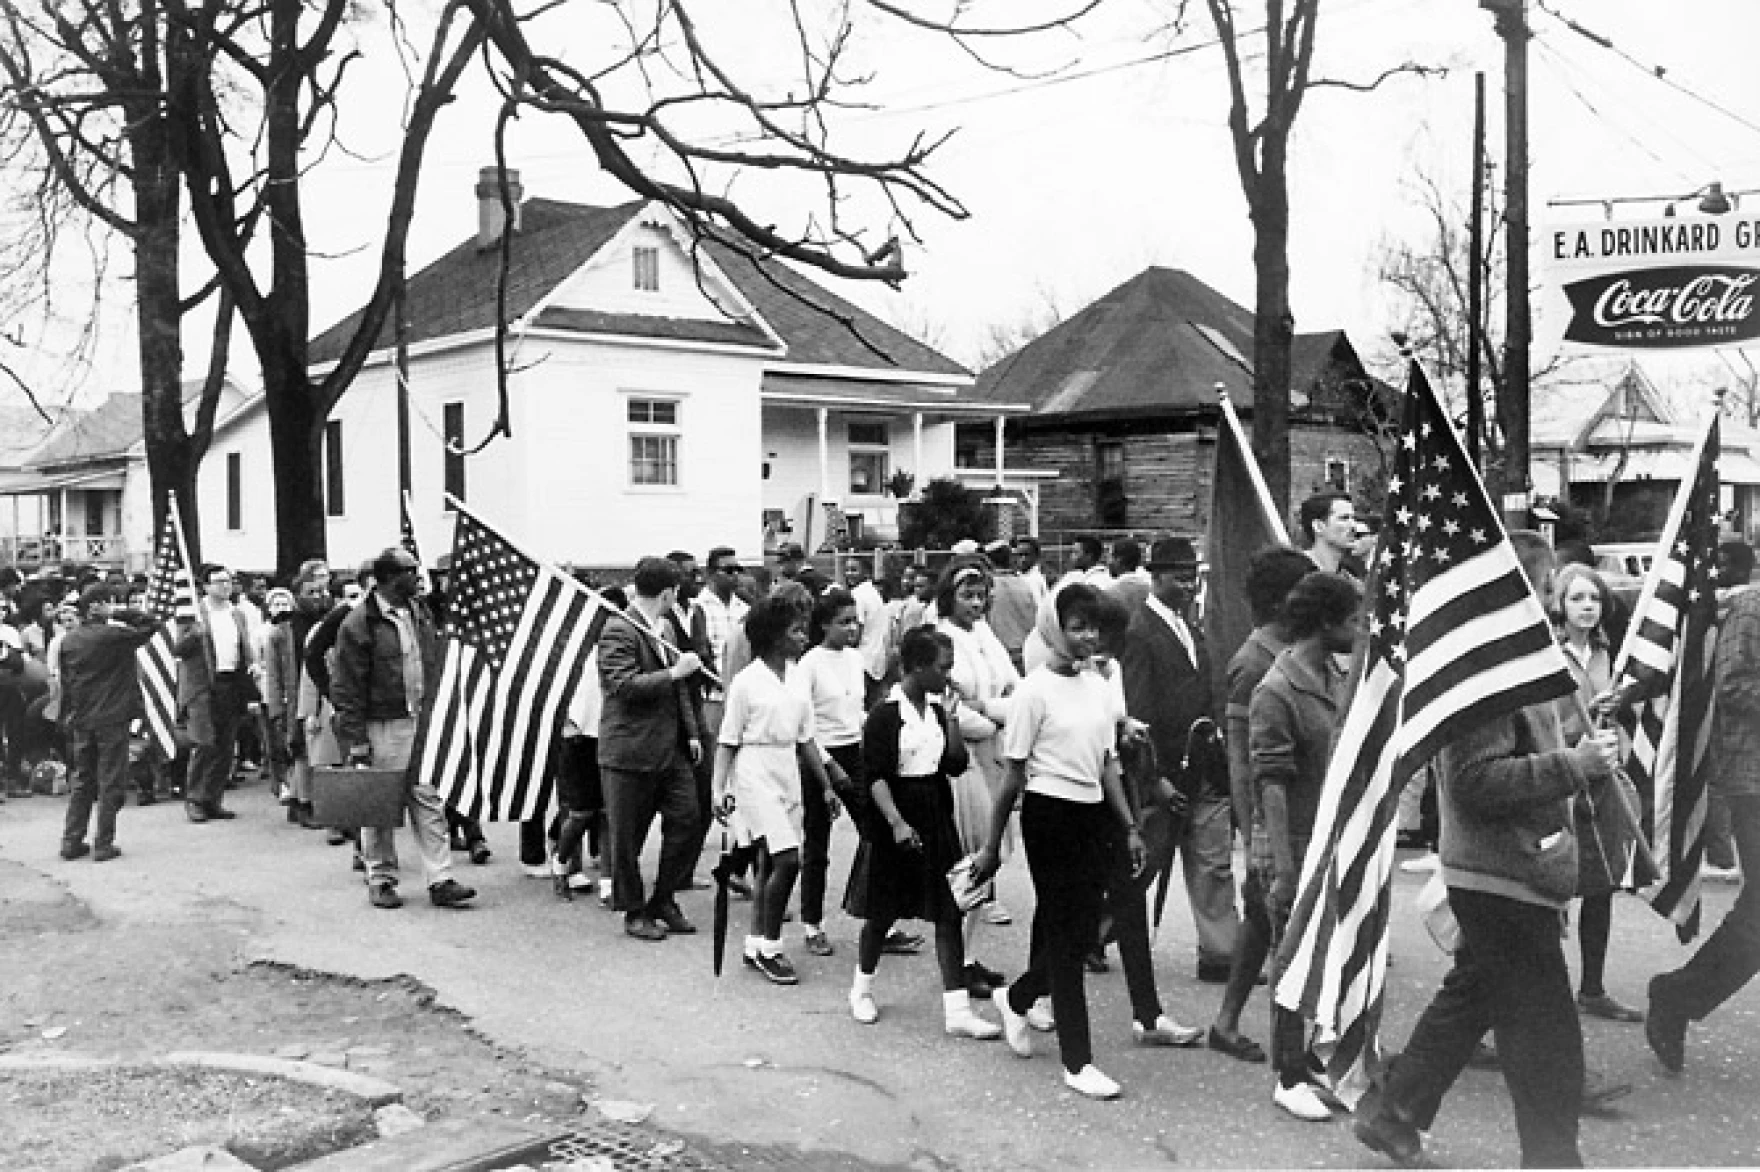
left=598, top=558, right=702, bottom=941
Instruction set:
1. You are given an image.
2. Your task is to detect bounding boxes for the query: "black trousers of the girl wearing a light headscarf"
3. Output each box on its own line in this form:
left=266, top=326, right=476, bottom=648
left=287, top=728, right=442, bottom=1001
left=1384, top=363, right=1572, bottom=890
left=1008, top=792, right=1116, bottom=1073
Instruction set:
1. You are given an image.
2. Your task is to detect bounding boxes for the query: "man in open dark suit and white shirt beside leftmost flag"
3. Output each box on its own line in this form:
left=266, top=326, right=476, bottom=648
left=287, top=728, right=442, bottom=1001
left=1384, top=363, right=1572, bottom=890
left=171, top=565, right=262, bottom=822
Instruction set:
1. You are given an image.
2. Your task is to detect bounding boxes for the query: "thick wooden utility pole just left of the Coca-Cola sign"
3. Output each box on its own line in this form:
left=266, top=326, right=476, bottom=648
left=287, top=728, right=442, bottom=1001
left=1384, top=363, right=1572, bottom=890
left=1478, top=0, right=1533, bottom=524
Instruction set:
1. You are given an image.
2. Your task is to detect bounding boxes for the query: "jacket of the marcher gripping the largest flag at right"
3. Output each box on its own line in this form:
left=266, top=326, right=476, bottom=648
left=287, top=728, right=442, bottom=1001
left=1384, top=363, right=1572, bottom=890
left=1436, top=704, right=1607, bottom=908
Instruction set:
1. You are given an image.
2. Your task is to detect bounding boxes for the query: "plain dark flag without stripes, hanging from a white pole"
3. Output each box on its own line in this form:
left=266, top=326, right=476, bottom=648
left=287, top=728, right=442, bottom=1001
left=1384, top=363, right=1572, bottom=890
left=1204, top=387, right=1290, bottom=713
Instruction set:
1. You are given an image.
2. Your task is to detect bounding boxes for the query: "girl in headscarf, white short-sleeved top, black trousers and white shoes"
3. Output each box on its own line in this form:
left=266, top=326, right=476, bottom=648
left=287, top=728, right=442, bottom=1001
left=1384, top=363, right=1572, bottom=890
left=972, top=584, right=1142, bottom=1098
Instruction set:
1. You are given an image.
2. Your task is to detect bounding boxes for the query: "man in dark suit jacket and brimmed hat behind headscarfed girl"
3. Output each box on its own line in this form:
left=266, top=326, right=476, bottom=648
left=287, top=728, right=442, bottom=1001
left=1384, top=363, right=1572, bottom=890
left=1121, top=537, right=1241, bottom=984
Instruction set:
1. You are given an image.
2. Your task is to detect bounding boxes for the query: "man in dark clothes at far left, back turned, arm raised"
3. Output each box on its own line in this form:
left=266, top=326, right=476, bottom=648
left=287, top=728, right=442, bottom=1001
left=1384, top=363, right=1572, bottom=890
left=62, top=584, right=155, bottom=862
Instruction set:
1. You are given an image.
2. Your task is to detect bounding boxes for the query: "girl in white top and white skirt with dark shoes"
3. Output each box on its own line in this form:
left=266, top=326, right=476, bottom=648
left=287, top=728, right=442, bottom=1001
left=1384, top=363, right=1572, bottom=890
left=713, top=595, right=838, bottom=985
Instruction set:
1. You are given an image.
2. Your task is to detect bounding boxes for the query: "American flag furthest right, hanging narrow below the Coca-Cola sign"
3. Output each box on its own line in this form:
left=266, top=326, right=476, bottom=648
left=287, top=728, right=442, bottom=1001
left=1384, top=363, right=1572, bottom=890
left=1614, top=415, right=1721, bottom=941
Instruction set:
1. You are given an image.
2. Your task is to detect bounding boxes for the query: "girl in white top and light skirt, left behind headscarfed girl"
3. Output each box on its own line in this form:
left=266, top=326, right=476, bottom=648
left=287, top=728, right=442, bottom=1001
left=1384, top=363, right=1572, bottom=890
left=935, top=558, right=1021, bottom=996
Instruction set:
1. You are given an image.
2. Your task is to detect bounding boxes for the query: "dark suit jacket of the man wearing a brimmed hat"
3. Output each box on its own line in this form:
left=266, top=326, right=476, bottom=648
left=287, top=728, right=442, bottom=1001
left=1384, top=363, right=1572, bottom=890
left=1119, top=605, right=1228, bottom=799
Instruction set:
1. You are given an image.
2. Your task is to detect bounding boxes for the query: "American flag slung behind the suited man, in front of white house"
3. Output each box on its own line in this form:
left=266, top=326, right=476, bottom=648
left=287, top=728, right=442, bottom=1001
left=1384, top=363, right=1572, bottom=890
left=417, top=509, right=611, bottom=822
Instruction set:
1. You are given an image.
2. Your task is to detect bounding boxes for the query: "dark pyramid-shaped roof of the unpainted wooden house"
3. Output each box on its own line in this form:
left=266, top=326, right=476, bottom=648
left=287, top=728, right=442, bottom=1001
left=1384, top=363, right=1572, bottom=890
left=972, top=267, right=1357, bottom=419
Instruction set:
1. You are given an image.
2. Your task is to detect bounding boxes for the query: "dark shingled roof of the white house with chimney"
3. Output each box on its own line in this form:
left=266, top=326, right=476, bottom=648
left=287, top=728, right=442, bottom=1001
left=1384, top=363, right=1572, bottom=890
left=310, top=199, right=968, bottom=377
